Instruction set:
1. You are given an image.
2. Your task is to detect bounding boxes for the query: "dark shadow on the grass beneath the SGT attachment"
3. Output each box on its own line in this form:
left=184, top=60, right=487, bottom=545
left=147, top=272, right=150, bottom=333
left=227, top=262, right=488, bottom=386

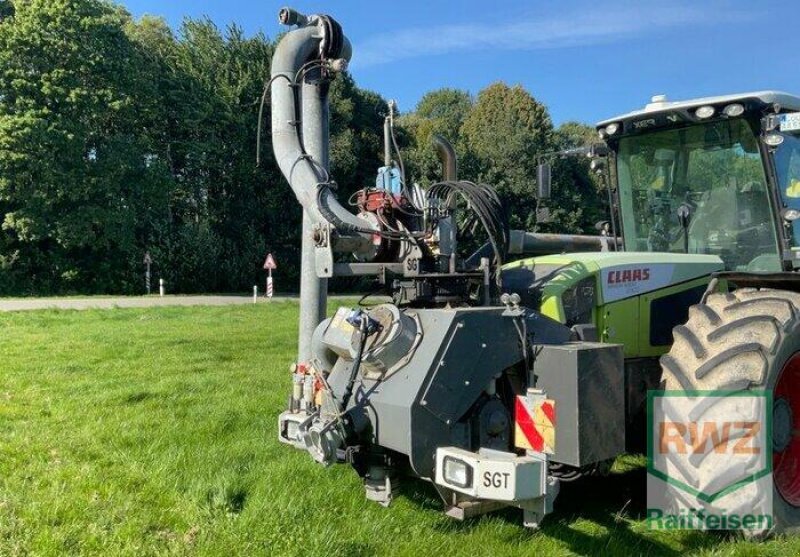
left=400, top=460, right=725, bottom=557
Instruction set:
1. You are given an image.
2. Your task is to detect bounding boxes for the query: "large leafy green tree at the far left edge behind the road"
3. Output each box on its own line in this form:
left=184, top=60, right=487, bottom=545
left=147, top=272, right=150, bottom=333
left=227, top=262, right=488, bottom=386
left=0, top=0, right=169, bottom=292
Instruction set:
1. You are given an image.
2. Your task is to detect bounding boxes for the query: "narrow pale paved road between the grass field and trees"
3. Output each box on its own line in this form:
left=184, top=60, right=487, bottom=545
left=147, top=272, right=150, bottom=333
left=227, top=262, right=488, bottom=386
left=0, top=296, right=296, bottom=311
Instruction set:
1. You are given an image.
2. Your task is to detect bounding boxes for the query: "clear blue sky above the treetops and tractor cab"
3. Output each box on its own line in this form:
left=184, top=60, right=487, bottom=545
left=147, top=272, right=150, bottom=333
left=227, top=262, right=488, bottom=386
left=122, top=0, right=800, bottom=124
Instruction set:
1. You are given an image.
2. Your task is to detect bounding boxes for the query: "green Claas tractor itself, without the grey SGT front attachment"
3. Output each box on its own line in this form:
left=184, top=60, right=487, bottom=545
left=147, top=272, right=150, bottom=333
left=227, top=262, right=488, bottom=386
left=503, top=91, right=800, bottom=531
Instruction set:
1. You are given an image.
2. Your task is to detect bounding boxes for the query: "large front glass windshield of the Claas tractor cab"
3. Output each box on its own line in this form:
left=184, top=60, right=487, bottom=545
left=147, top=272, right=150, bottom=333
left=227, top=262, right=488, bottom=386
left=617, top=118, right=780, bottom=271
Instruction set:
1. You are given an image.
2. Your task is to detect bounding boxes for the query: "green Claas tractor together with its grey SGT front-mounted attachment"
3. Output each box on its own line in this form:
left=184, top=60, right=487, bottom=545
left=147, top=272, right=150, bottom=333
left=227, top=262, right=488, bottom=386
left=268, top=8, right=800, bottom=532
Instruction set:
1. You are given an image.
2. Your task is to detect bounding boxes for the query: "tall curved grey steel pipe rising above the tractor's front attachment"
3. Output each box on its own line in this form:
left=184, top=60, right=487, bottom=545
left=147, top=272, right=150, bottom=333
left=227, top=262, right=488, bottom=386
left=270, top=8, right=371, bottom=362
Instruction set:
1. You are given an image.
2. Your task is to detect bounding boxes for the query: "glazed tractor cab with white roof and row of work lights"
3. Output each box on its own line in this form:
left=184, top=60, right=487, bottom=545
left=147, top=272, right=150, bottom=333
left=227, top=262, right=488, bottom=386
left=598, top=91, right=800, bottom=272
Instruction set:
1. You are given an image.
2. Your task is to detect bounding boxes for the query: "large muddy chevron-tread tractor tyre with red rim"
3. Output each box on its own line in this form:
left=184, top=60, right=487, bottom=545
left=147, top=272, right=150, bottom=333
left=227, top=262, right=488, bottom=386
left=661, top=288, right=800, bottom=533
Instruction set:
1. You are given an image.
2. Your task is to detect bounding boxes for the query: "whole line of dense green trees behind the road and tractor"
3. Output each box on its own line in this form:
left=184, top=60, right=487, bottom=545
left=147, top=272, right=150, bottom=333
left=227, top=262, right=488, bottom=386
left=0, top=0, right=604, bottom=295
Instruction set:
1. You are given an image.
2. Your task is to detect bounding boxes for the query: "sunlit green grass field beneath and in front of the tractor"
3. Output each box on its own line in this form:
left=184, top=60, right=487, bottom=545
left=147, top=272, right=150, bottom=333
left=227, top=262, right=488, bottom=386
left=0, top=303, right=800, bottom=557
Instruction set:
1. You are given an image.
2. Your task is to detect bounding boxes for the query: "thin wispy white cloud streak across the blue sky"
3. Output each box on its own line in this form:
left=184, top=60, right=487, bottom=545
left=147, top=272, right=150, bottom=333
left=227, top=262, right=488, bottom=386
left=353, top=2, right=753, bottom=68
